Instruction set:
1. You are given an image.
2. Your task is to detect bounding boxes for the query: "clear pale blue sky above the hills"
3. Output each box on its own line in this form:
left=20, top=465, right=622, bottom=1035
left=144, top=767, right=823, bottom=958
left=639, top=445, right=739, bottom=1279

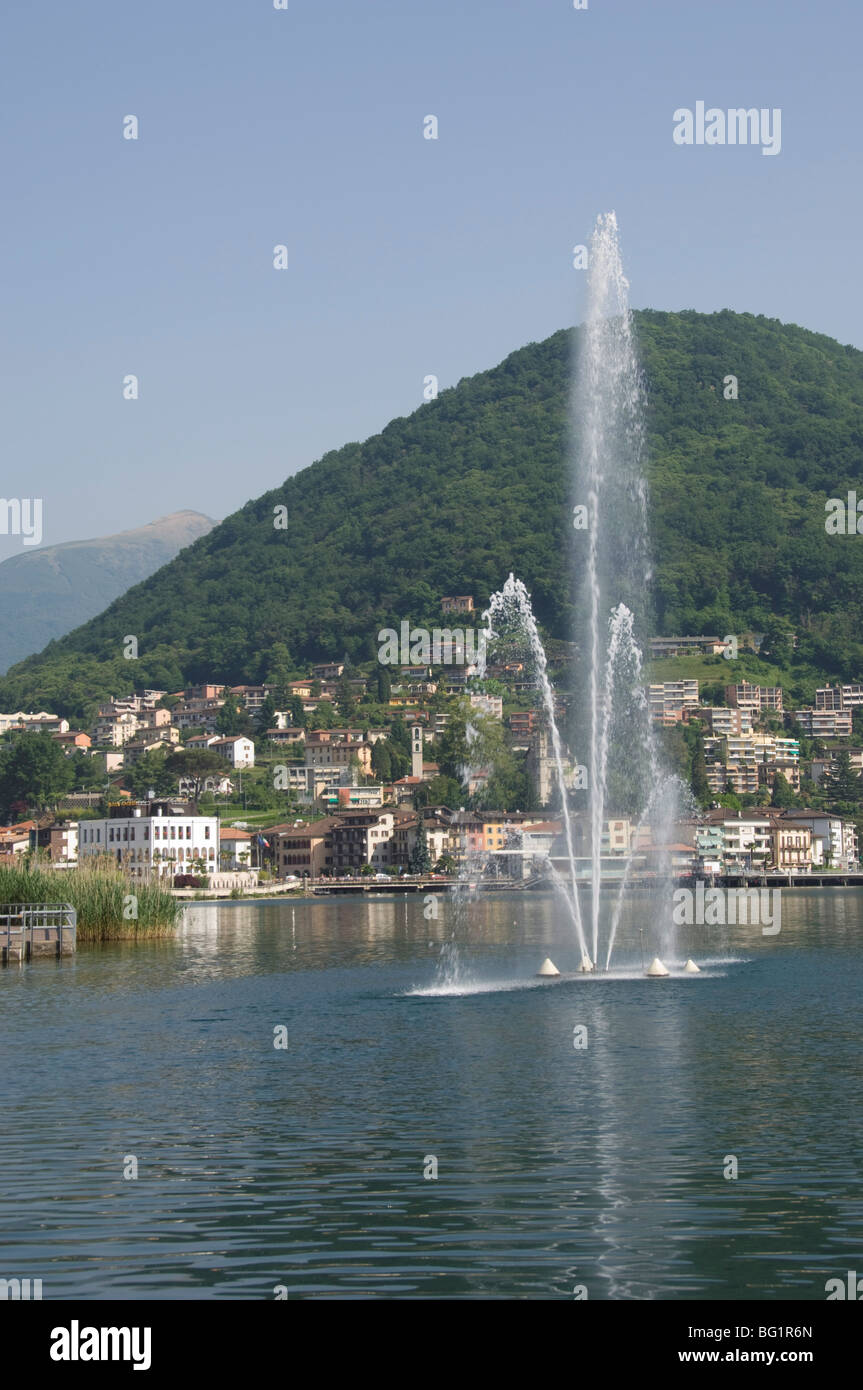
left=0, top=0, right=863, bottom=559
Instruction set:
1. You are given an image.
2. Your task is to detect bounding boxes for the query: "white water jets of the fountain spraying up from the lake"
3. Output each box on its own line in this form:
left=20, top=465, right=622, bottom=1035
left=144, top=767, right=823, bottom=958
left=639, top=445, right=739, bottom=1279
left=478, top=213, right=681, bottom=977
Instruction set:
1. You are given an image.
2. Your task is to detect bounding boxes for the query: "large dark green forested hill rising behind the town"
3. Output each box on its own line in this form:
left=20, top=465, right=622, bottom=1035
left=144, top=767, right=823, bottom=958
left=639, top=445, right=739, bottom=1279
left=0, top=311, right=863, bottom=717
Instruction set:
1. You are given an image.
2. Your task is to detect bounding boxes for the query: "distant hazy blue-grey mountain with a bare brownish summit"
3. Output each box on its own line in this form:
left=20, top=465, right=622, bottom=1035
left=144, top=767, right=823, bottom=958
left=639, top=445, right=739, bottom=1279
left=0, top=512, right=215, bottom=671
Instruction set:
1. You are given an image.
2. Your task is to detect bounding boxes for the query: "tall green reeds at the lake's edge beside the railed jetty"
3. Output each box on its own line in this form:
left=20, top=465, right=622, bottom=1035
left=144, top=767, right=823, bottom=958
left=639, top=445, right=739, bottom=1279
left=0, top=863, right=182, bottom=941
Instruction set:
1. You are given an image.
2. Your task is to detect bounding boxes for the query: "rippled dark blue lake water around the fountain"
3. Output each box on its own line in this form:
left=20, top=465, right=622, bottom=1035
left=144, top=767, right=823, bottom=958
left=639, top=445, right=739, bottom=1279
left=0, top=888, right=863, bottom=1300
